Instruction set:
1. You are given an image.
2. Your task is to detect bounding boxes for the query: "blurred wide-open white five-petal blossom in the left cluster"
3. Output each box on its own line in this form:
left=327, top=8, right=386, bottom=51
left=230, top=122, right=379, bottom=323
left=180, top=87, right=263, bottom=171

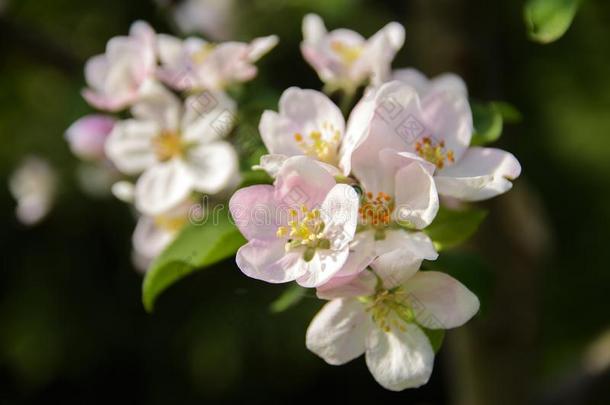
left=106, top=82, right=238, bottom=215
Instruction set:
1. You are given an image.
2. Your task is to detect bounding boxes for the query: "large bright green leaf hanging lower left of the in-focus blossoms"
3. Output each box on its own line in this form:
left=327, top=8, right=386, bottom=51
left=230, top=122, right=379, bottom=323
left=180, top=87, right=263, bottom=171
left=142, top=208, right=245, bottom=312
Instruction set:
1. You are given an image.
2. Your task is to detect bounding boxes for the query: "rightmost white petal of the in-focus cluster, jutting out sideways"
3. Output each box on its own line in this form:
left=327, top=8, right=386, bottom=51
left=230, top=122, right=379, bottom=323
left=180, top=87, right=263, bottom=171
left=435, top=147, right=521, bottom=201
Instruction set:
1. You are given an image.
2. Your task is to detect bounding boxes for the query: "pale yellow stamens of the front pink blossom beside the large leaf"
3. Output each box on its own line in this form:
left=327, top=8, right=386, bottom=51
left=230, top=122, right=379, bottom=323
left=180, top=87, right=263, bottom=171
left=276, top=205, right=330, bottom=261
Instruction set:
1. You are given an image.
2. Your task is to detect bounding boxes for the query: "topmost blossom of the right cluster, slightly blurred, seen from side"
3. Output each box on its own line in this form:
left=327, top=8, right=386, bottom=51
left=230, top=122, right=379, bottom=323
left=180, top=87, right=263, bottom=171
left=301, top=14, right=405, bottom=94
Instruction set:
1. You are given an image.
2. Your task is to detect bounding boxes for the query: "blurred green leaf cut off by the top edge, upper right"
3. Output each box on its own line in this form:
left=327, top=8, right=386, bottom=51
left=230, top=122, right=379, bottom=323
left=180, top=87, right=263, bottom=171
left=523, top=0, right=580, bottom=44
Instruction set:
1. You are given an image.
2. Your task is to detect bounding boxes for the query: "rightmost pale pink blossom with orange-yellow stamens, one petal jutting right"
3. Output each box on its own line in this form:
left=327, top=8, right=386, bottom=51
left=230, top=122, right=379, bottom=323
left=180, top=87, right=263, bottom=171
left=352, top=79, right=521, bottom=201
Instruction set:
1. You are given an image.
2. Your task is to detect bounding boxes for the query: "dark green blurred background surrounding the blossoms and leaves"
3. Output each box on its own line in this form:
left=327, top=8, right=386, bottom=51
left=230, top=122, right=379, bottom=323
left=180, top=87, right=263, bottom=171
left=0, top=0, right=610, bottom=404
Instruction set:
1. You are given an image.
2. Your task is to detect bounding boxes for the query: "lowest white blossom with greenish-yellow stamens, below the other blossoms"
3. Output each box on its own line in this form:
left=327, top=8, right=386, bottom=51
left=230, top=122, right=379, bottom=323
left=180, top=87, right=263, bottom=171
left=306, top=266, right=479, bottom=391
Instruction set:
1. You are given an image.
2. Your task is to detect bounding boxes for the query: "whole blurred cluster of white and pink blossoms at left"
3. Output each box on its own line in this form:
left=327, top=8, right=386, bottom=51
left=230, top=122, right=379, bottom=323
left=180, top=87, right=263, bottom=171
left=66, top=21, right=277, bottom=269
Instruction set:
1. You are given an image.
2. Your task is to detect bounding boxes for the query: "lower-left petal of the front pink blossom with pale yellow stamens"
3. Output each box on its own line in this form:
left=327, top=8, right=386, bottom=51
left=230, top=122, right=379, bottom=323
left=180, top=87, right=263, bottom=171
left=235, top=239, right=305, bottom=283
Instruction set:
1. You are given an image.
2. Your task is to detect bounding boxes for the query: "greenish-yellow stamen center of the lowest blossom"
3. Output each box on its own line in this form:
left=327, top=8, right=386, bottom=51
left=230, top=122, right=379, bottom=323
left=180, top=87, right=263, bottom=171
left=366, top=287, right=415, bottom=332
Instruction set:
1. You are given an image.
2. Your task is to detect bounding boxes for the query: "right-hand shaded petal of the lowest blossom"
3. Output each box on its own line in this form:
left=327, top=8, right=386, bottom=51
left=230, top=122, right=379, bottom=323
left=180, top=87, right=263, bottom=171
left=403, top=271, right=479, bottom=329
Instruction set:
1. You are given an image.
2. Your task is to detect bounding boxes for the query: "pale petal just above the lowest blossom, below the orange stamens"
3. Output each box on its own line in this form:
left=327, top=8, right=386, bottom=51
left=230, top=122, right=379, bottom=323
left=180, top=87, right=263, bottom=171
left=371, top=229, right=438, bottom=288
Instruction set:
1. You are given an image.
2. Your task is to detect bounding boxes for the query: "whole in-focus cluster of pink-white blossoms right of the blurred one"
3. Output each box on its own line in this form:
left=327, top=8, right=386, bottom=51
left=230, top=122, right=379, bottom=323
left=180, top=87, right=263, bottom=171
left=230, top=15, right=521, bottom=390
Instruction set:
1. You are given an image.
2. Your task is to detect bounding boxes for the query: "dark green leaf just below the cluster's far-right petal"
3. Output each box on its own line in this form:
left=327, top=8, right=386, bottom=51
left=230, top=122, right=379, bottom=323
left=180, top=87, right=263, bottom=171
left=424, top=207, right=487, bottom=251
